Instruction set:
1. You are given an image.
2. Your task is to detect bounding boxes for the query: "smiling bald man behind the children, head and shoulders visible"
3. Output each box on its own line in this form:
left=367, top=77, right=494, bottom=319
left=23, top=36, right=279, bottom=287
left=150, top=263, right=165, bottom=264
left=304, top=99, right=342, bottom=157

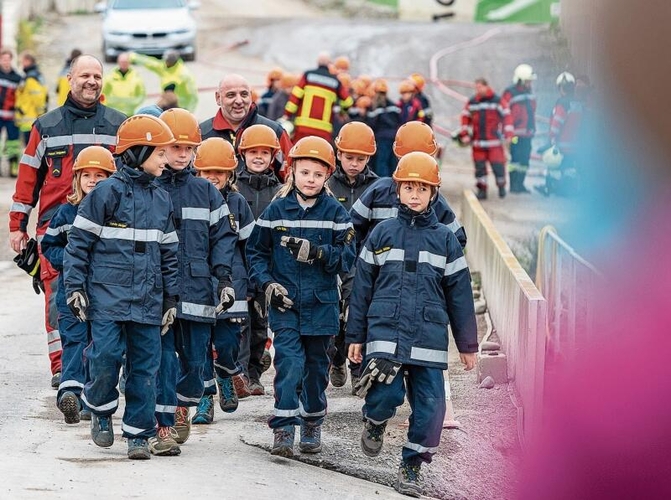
left=200, top=74, right=292, bottom=173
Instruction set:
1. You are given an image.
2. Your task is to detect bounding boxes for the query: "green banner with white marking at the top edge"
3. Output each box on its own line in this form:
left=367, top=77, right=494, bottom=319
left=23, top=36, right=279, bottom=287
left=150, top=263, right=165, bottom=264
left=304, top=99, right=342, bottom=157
left=475, top=0, right=559, bottom=23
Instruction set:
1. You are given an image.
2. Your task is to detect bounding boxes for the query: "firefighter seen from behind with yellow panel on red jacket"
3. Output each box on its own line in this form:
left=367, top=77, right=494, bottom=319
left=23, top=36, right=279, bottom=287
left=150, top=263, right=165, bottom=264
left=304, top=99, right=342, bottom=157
left=284, top=52, right=354, bottom=143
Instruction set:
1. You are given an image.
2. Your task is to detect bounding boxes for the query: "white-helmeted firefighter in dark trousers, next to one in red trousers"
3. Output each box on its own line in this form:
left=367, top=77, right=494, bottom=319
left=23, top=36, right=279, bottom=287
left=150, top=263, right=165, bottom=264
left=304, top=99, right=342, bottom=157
left=501, top=64, right=536, bottom=193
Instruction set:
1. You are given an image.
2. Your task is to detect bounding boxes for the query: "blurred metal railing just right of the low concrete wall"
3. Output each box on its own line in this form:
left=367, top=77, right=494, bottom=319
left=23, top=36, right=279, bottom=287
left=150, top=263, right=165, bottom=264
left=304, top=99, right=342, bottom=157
left=536, top=226, right=601, bottom=364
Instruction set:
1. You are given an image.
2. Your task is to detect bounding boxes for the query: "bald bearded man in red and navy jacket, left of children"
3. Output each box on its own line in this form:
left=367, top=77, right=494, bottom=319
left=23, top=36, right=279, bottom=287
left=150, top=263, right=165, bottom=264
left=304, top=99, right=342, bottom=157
left=9, top=55, right=126, bottom=389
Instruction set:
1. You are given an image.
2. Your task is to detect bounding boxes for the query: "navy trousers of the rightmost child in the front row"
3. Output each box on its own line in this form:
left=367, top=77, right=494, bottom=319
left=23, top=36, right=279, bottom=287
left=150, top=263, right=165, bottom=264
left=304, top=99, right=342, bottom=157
left=361, top=360, right=445, bottom=465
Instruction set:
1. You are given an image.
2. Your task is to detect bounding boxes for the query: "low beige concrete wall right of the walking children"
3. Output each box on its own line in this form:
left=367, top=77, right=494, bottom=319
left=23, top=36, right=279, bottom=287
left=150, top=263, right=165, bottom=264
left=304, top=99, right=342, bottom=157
left=461, top=190, right=547, bottom=441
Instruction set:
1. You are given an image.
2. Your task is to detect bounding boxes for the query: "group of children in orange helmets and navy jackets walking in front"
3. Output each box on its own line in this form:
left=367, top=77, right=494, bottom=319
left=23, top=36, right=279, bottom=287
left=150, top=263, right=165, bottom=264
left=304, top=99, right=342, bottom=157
left=42, top=108, right=477, bottom=496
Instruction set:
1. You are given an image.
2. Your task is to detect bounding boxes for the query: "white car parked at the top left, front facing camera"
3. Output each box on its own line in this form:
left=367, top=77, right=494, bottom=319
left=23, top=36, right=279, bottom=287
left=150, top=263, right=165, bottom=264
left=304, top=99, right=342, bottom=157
left=95, top=0, right=200, bottom=62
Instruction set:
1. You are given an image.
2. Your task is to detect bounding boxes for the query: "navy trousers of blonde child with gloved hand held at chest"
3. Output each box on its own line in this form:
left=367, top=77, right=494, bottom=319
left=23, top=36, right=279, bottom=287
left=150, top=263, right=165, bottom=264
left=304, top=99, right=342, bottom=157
left=268, top=328, right=331, bottom=429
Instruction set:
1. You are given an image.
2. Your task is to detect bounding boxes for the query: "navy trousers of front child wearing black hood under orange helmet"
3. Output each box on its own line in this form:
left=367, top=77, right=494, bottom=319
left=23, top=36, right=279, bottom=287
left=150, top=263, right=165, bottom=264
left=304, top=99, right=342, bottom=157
left=82, top=321, right=161, bottom=438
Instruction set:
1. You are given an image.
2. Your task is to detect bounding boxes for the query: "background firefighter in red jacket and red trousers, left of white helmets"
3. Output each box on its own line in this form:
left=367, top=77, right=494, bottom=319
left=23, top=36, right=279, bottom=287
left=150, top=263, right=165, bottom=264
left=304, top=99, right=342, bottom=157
left=458, top=78, right=513, bottom=200
